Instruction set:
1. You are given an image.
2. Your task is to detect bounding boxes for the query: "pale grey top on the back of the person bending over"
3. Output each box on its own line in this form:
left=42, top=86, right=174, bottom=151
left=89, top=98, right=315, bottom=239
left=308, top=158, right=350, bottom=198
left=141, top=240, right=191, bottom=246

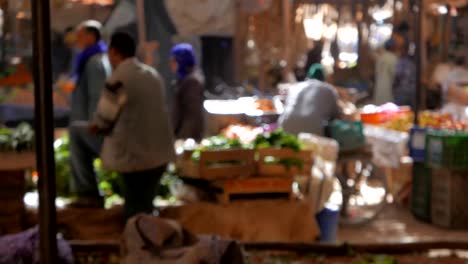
left=279, top=80, right=340, bottom=135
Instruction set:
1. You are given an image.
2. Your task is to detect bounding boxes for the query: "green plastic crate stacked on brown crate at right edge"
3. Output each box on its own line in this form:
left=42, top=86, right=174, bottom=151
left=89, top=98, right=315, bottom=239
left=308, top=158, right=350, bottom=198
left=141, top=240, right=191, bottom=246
left=425, top=131, right=468, bottom=169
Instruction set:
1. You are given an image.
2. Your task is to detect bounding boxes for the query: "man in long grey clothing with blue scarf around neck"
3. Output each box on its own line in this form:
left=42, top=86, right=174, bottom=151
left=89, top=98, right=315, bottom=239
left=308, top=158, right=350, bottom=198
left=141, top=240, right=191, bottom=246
left=70, top=20, right=111, bottom=207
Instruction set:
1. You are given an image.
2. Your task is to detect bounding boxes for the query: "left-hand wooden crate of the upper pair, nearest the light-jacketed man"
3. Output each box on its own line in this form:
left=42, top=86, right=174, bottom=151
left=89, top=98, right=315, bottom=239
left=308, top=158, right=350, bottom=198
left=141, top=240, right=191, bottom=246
left=179, top=149, right=255, bottom=180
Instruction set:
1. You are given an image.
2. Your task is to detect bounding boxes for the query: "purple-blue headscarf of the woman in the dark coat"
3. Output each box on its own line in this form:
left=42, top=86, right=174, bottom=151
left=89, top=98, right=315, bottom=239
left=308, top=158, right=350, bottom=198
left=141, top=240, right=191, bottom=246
left=171, top=43, right=197, bottom=80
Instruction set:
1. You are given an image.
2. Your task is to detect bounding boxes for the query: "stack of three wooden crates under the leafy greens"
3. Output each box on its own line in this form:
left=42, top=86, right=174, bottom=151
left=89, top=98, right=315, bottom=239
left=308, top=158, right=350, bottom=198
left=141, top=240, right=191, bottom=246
left=178, top=148, right=313, bottom=203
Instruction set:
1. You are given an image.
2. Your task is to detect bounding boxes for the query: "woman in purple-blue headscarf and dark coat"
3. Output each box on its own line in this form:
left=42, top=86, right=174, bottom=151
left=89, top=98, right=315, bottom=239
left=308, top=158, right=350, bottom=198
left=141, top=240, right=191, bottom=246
left=170, top=43, right=205, bottom=140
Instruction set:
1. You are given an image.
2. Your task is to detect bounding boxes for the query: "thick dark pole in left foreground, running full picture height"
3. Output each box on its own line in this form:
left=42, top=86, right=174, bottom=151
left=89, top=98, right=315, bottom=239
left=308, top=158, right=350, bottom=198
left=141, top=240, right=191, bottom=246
left=31, top=0, right=57, bottom=264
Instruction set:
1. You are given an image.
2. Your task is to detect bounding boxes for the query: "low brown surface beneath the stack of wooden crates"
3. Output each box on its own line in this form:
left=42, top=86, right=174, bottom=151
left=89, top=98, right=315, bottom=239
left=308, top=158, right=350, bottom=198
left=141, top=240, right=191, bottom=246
left=161, top=200, right=319, bottom=242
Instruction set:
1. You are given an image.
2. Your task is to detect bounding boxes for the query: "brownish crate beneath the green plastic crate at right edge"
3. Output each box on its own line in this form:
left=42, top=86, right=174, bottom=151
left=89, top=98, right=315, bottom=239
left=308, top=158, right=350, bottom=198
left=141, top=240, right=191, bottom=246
left=431, top=169, right=468, bottom=229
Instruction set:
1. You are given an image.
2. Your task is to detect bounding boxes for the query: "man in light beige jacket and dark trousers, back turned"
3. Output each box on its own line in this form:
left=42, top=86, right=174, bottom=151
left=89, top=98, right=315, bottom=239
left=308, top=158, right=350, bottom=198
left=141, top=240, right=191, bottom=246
left=91, top=33, right=175, bottom=219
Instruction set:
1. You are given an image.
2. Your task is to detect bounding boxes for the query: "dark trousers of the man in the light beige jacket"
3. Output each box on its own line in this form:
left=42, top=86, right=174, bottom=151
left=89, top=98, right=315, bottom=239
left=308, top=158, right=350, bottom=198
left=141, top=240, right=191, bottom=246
left=122, top=165, right=167, bottom=220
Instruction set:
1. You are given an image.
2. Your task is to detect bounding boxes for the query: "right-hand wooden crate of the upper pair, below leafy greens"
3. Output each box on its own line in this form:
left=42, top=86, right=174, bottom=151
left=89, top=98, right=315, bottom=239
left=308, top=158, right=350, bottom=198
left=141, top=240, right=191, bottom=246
left=257, top=148, right=313, bottom=177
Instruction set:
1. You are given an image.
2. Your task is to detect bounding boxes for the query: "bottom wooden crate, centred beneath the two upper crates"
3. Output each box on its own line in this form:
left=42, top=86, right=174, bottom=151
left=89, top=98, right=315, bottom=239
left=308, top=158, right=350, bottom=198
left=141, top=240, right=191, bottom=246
left=216, top=177, right=293, bottom=204
